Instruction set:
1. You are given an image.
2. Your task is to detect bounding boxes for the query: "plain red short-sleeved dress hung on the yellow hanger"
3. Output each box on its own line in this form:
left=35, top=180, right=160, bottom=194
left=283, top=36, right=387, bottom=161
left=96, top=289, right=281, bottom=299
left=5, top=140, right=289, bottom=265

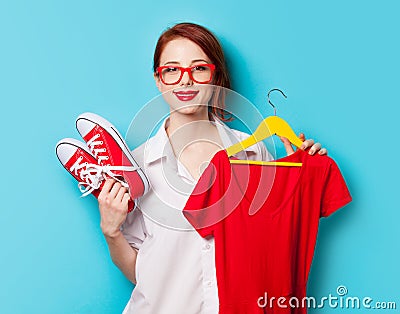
left=184, top=150, right=351, bottom=314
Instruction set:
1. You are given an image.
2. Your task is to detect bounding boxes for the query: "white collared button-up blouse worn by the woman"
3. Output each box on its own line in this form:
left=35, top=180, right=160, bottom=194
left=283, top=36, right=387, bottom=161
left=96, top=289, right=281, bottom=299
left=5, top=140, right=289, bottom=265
left=119, top=118, right=272, bottom=314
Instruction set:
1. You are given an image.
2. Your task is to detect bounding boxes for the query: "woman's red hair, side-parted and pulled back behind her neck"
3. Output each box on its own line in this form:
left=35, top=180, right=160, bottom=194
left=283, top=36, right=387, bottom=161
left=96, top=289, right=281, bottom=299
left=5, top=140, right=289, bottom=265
left=153, top=23, right=231, bottom=120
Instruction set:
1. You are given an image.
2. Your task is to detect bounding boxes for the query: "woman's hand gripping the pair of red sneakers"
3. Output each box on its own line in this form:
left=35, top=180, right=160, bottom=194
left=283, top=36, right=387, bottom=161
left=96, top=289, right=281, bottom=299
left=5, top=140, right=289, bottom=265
left=98, top=179, right=130, bottom=238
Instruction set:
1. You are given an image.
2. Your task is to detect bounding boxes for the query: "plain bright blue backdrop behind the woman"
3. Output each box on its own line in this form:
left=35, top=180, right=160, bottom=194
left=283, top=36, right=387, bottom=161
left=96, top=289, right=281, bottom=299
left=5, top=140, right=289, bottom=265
left=0, top=0, right=400, bottom=313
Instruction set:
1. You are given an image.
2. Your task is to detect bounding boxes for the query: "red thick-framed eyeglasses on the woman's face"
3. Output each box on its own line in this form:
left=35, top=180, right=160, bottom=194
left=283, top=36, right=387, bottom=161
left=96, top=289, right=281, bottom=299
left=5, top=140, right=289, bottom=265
left=157, top=63, right=215, bottom=85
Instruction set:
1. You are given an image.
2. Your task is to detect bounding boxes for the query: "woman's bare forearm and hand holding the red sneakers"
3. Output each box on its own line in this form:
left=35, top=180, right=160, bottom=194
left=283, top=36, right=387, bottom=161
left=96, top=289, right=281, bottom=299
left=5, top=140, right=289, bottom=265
left=98, top=179, right=137, bottom=284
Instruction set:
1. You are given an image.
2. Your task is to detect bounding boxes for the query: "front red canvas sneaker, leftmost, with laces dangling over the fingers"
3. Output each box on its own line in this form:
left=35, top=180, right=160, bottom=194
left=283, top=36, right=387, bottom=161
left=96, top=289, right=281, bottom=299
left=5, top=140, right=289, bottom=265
left=56, top=138, right=134, bottom=212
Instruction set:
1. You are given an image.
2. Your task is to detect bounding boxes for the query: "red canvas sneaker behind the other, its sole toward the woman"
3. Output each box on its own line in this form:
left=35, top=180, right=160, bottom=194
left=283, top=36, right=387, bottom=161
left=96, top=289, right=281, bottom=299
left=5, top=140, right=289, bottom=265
left=76, top=112, right=149, bottom=199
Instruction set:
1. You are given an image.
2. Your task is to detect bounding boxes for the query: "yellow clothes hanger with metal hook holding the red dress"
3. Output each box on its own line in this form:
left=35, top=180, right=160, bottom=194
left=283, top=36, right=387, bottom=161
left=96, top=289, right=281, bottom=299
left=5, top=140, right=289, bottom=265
left=226, top=89, right=303, bottom=166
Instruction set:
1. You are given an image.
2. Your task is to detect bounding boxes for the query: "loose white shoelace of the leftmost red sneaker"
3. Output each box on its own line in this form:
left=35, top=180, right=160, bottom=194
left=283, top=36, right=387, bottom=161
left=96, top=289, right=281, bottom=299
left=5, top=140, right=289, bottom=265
left=70, top=156, right=137, bottom=197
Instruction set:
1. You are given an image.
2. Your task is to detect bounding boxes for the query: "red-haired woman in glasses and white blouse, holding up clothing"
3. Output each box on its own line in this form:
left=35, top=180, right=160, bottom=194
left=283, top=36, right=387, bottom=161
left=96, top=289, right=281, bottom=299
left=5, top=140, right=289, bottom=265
left=98, top=23, right=326, bottom=314
